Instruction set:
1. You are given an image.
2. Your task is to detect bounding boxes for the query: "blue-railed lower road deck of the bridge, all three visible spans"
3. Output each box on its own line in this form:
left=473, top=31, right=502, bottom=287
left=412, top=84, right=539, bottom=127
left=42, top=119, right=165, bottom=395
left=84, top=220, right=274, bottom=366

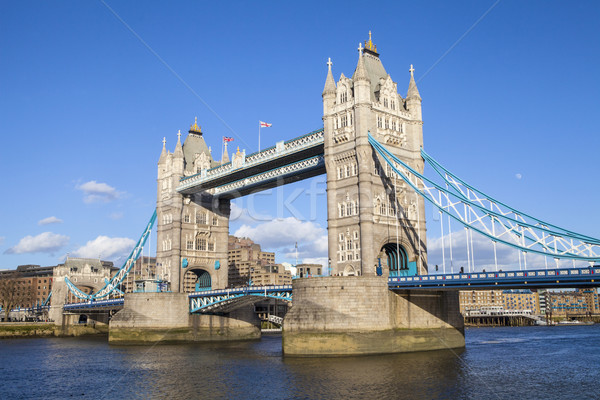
left=64, top=265, right=600, bottom=313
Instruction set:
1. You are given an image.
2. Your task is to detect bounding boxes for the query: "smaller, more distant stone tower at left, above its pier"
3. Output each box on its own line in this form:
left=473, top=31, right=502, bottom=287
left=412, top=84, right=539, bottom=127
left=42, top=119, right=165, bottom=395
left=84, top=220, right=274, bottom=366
left=156, top=120, right=230, bottom=292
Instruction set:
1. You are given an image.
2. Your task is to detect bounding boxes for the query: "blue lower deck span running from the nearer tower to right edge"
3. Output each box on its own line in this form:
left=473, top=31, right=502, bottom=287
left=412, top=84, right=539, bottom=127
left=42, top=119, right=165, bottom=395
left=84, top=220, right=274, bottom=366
left=388, top=265, right=600, bottom=290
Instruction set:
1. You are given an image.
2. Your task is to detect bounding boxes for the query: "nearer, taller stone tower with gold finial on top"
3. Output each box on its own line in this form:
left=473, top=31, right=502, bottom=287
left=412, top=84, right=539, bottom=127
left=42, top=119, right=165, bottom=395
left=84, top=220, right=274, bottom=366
left=323, top=32, right=427, bottom=276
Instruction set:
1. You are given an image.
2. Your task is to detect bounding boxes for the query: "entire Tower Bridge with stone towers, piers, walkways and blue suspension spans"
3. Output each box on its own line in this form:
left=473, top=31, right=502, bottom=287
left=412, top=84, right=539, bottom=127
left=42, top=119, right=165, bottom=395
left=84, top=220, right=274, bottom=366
left=52, top=33, right=600, bottom=356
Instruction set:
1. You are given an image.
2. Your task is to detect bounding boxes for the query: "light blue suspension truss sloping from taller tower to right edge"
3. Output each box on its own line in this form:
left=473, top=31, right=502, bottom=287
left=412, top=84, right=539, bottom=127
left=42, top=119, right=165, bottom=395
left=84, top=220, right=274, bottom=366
left=369, top=133, right=600, bottom=267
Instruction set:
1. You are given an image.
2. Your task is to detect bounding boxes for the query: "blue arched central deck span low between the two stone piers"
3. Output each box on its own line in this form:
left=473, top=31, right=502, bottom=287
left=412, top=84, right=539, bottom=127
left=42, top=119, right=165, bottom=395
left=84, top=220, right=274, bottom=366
left=189, top=285, right=292, bottom=313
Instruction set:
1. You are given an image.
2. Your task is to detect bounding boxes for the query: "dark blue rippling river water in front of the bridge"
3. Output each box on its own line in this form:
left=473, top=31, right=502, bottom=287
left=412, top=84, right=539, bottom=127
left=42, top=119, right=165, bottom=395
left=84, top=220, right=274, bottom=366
left=0, top=325, right=600, bottom=399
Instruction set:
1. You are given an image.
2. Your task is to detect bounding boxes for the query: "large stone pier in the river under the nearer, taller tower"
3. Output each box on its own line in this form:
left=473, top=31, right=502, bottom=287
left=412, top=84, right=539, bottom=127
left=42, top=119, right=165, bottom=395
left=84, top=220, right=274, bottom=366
left=283, top=276, right=465, bottom=356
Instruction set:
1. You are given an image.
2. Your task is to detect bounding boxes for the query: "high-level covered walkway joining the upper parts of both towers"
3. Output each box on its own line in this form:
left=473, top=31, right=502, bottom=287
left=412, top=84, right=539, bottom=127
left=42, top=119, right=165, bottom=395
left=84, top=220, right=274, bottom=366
left=176, top=129, right=325, bottom=198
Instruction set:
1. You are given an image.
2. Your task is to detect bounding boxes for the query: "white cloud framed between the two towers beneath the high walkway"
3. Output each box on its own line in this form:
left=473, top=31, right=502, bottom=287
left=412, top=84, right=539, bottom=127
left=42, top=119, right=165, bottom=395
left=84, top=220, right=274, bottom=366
left=235, top=217, right=328, bottom=258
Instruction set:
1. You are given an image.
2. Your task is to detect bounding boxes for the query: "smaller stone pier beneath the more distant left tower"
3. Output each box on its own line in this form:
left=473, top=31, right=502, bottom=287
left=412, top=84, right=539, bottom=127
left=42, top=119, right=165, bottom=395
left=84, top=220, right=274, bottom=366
left=108, top=293, right=260, bottom=344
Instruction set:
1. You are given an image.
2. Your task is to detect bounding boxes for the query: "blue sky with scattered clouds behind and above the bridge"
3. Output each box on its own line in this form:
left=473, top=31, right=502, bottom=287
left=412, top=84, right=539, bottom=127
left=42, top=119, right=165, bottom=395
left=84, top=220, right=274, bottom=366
left=0, top=0, right=600, bottom=269
